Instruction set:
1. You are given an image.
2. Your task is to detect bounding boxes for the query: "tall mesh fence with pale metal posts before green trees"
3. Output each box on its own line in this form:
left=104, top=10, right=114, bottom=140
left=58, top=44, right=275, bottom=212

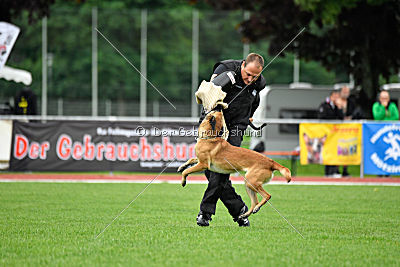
left=0, top=7, right=344, bottom=116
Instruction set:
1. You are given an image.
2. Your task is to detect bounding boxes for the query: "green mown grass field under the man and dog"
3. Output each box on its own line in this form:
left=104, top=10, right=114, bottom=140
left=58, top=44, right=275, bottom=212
left=0, top=183, right=400, bottom=266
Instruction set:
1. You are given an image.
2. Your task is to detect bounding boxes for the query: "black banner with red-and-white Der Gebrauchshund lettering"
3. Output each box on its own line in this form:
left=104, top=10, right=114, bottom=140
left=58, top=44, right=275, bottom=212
left=10, top=121, right=197, bottom=172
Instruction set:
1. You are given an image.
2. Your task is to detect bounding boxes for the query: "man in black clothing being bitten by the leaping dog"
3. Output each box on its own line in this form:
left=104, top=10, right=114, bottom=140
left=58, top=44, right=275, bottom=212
left=197, top=53, right=266, bottom=226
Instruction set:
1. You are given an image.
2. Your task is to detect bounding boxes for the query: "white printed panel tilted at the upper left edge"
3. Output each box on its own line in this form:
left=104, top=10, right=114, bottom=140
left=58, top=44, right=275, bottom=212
left=0, top=22, right=20, bottom=70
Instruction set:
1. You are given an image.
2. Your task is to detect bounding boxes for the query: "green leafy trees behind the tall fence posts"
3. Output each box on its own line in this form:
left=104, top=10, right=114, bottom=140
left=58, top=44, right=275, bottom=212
left=0, top=0, right=354, bottom=116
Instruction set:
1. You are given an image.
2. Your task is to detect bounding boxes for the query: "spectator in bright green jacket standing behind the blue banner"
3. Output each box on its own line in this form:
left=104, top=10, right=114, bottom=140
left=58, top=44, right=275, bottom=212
left=372, top=91, right=399, bottom=121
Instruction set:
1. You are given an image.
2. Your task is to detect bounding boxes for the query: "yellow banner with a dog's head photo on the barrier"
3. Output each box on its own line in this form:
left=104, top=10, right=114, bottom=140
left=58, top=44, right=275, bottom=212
left=299, top=123, right=362, bottom=165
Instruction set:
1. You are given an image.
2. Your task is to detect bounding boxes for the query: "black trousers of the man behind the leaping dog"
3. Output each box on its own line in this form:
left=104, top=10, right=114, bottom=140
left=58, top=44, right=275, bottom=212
left=200, top=131, right=245, bottom=218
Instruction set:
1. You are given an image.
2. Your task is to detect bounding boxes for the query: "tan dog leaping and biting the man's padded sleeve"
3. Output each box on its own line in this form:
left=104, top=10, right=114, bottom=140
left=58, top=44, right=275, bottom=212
left=178, top=111, right=291, bottom=218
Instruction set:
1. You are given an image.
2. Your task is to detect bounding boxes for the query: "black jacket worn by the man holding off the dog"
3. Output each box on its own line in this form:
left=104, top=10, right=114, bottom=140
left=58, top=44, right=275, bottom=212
left=200, top=60, right=266, bottom=130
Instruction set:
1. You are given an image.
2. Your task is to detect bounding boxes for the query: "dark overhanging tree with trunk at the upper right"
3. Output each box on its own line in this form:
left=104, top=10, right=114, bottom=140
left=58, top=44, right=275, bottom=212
left=203, top=0, right=400, bottom=116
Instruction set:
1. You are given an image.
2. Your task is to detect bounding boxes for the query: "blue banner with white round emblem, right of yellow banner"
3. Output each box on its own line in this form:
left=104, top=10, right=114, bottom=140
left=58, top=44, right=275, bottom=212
left=363, top=123, right=400, bottom=175
